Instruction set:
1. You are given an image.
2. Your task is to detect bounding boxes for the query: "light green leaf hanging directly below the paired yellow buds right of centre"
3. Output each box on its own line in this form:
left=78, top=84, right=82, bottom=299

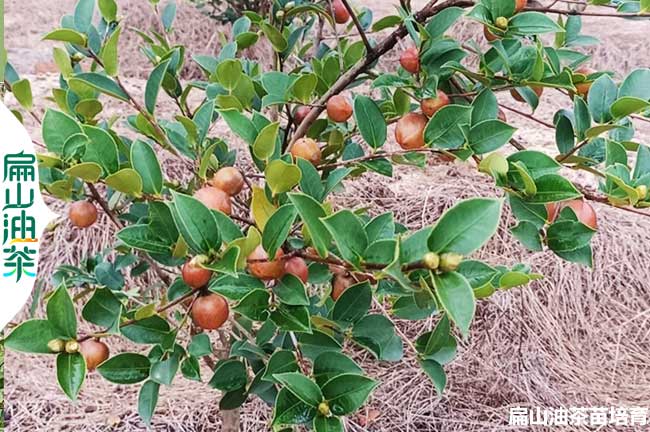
left=433, top=272, right=476, bottom=337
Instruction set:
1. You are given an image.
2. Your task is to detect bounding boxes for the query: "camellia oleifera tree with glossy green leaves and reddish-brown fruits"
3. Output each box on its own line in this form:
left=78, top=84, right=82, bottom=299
left=6, top=0, right=650, bottom=432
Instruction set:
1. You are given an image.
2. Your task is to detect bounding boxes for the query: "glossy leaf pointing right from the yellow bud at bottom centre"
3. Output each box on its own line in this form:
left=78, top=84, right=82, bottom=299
left=322, top=374, right=377, bottom=415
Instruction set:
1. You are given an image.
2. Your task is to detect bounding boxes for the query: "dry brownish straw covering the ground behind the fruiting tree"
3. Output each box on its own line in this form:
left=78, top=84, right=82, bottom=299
left=5, top=0, right=650, bottom=432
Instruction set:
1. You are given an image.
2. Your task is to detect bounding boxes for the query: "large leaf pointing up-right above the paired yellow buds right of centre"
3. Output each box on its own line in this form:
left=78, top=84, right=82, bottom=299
left=428, top=198, right=503, bottom=255
